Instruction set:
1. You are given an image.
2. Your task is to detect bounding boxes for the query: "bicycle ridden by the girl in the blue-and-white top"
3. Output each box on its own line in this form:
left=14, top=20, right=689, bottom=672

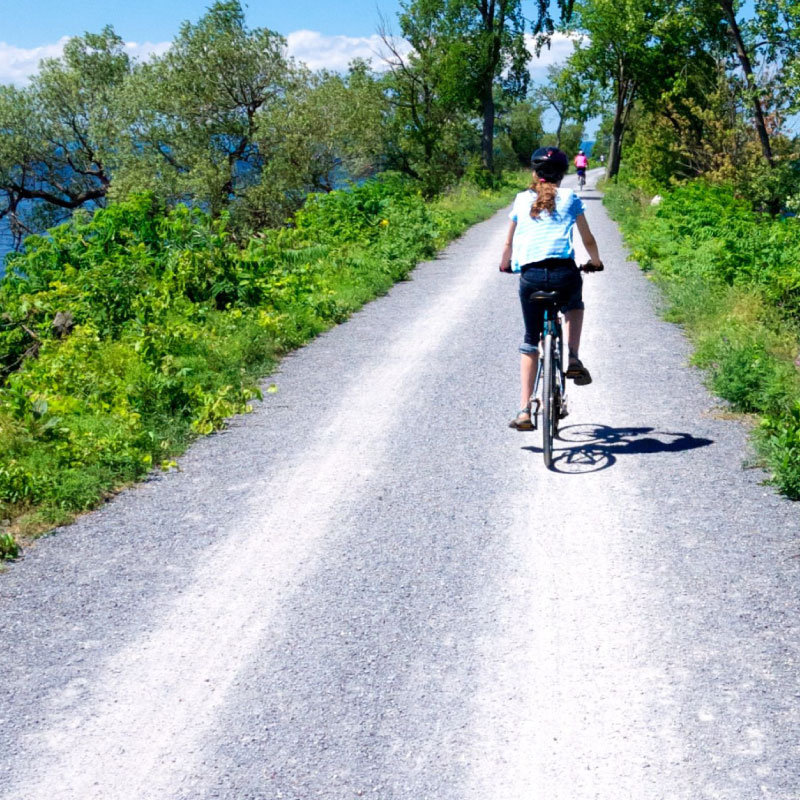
left=529, top=263, right=603, bottom=469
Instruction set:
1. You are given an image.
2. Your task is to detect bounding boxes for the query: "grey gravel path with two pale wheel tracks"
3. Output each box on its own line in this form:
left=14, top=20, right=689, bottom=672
left=0, top=170, right=800, bottom=800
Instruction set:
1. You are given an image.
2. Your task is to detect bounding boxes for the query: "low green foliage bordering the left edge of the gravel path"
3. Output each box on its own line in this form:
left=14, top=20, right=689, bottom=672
left=0, top=175, right=511, bottom=529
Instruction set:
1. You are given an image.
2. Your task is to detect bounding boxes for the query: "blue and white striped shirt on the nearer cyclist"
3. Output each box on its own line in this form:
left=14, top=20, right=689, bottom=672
left=508, top=189, right=586, bottom=272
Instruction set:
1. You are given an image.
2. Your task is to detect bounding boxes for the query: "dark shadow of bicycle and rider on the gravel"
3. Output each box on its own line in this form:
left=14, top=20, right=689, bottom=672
left=523, top=424, right=714, bottom=474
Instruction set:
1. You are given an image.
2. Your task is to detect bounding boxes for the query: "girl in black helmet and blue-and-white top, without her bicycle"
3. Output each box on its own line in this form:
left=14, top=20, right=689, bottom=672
left=500, top=147, right=603, bottom=430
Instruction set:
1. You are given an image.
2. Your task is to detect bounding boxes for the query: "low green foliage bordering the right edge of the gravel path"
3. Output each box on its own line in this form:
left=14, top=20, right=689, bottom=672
left=606, top=180, right=800, bottom=499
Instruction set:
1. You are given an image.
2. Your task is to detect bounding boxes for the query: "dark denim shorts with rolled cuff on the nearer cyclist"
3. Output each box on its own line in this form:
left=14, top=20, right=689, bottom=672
left=519, top=258, right=583, bottom=354
